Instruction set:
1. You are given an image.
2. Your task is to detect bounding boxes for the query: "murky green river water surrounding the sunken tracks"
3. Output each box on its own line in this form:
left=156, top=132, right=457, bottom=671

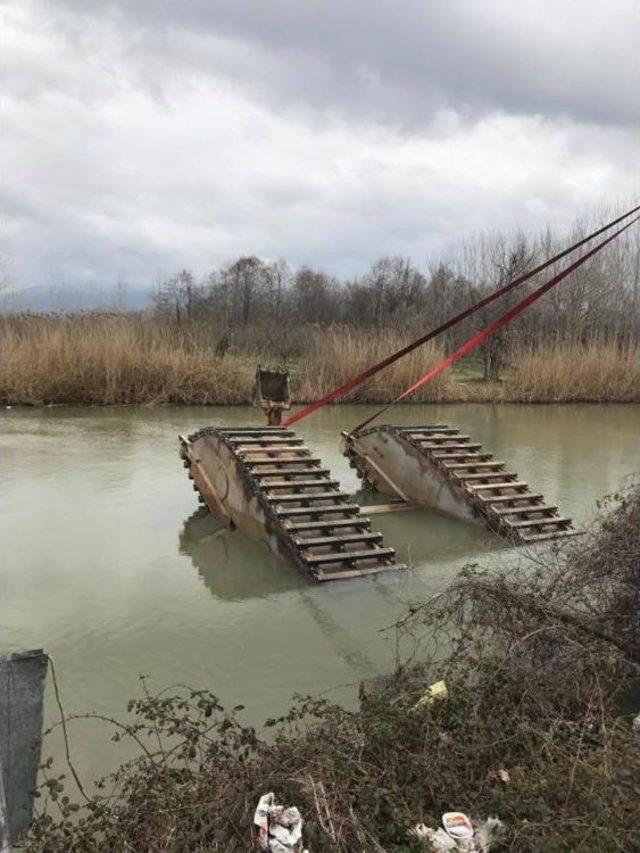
left=0, top=405, right=640, bottom=777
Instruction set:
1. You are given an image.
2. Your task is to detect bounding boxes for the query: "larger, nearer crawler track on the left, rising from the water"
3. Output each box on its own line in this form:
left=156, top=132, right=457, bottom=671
left=181, top=427, right=406, bottom=581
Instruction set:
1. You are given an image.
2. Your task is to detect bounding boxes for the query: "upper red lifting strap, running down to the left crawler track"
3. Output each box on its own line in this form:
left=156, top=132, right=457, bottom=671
left=281, top=205, right=640, bottom=427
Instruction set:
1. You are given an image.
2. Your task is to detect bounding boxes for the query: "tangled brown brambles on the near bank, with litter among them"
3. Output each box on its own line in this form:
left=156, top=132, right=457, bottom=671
left=27, top=486, right=640, bottom=853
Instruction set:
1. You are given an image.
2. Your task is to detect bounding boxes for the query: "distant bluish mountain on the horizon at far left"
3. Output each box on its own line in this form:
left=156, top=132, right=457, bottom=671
left=0, top=284, right=152, bottom=314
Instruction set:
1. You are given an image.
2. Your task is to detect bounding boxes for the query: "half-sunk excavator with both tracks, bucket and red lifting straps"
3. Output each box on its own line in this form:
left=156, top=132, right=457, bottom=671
left=180, top=206, right=640, bottom=581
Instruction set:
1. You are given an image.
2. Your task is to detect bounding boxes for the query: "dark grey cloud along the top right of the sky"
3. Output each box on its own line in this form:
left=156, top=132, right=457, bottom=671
left=57, top=0, right=640, bottom=128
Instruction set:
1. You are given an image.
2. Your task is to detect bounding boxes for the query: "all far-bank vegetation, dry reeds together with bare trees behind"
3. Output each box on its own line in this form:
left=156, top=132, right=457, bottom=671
left=0, top=211, right=640, bottom=405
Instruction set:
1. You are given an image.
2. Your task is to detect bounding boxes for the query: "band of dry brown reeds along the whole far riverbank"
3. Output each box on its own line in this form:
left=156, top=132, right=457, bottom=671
left=0, top=313, right=640, bottom=405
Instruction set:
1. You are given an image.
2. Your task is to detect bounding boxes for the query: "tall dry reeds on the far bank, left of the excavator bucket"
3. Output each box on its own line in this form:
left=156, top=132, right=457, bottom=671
left=0, top=314, right=255, bottom=405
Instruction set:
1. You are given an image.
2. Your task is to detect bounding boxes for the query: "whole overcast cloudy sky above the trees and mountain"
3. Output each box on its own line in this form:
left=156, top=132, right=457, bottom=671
left=0, top=0, right=640, bottom=286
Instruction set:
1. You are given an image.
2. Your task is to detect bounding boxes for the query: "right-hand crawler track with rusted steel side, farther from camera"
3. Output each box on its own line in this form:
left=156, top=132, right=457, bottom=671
left=344, top=424, right=576, bottom=543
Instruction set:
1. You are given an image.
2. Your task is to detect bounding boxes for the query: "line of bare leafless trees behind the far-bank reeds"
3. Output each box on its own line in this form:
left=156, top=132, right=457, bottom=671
left=155, top=216, right=640, bottom=378
